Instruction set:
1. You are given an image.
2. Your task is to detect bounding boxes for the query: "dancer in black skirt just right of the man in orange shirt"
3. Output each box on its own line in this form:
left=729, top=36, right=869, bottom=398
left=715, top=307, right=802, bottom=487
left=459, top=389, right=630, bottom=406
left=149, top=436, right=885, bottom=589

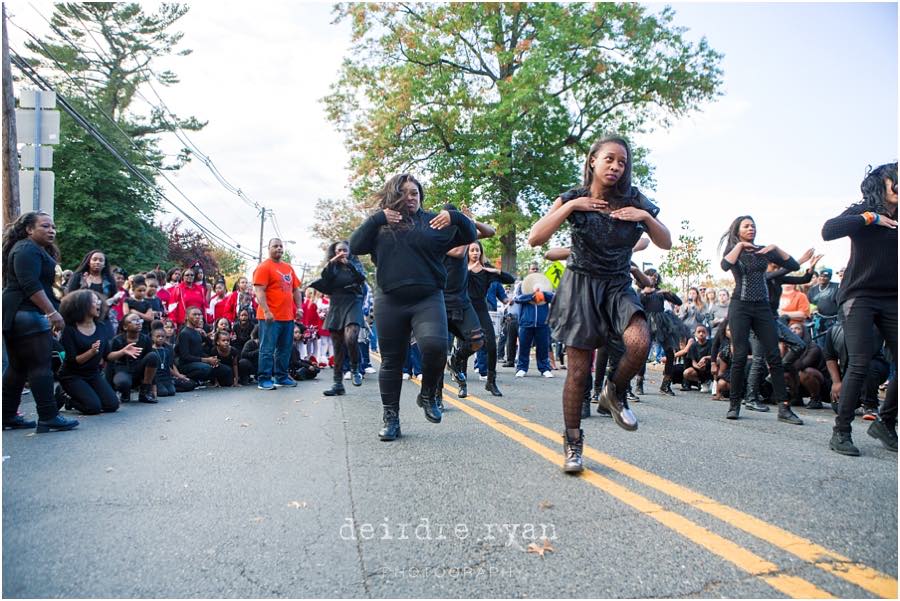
left=310, top=241, right=366, bottom=396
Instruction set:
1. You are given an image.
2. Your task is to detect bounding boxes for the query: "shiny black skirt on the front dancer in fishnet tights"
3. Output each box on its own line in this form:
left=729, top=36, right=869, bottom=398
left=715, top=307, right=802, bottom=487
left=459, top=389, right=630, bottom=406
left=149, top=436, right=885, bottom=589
left=549, top=269, right=644, bottom=350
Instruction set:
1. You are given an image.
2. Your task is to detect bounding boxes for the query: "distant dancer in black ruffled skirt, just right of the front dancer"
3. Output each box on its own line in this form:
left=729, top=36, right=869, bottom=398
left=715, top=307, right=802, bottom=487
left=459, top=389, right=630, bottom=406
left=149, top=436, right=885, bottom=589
left=635, top=269, right=690, bottom=396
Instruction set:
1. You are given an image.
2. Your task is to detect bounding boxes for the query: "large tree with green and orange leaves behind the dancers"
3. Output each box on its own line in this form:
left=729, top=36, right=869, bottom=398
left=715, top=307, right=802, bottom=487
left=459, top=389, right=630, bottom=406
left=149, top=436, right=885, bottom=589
left=324, top=2, right=721, bottom=270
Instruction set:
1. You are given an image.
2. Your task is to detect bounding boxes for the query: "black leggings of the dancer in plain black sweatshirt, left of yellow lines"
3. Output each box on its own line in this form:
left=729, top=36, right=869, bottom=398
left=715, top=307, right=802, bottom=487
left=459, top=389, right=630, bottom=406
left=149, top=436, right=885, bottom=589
left=375, top=290, right=447, bottom=411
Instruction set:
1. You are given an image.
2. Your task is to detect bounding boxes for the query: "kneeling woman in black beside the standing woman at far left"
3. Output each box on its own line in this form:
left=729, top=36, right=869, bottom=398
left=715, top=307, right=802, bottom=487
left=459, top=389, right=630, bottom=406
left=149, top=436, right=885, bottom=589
left=59, top=289, right=119, bottom=415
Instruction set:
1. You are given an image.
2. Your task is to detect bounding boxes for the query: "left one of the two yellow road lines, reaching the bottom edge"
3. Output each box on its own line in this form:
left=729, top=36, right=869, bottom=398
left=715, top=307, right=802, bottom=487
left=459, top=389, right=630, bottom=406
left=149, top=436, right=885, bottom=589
left=444, top=386, right=834, bottom=599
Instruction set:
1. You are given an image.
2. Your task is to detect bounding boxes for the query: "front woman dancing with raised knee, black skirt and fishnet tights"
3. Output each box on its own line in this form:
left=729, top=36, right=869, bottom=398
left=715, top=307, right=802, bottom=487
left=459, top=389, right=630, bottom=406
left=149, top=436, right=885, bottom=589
left=528, top=137, right=672, bottom=473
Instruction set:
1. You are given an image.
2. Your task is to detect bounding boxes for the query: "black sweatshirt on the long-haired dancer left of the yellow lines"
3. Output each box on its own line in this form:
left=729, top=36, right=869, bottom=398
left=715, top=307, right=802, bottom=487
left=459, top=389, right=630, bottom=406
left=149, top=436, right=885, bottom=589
left=350, top=209, right=478, bottom=293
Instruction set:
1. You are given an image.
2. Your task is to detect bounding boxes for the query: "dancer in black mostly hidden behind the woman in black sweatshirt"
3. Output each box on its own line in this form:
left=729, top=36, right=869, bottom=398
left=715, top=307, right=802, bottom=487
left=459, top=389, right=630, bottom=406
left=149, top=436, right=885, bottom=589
left=437, top=204, right=494, bottom=398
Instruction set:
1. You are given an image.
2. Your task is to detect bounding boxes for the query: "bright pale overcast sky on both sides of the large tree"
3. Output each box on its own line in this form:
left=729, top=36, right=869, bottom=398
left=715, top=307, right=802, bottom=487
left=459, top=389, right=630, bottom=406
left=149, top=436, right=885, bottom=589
left=7, top=1, right=898, bottom=277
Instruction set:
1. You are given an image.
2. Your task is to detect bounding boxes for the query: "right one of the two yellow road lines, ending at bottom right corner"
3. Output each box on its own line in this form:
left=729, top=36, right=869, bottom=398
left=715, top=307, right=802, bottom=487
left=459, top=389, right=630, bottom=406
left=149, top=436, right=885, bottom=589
left=445, top=386, right=897, bottom=599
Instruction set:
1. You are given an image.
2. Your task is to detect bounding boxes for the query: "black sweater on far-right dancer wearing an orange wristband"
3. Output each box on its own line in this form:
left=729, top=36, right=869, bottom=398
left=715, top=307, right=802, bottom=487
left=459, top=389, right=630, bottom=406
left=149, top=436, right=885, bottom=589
left=822, top=203, right=897, bottom=304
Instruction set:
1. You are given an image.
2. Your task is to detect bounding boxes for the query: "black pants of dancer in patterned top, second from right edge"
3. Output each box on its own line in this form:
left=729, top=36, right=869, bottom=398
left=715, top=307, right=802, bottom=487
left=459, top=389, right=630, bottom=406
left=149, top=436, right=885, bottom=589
left=728, top=299, right=788, bottom=403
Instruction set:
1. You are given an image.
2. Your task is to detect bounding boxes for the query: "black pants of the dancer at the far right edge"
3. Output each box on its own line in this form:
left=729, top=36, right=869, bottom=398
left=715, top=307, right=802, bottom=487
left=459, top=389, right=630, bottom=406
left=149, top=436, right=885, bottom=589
left=834, top=296, right=897, bottom=432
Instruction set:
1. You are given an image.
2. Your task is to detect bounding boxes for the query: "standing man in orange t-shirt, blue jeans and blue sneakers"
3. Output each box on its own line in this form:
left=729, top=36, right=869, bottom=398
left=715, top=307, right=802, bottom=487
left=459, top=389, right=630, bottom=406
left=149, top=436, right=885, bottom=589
left=253, top=238, right=301, bottom=390
